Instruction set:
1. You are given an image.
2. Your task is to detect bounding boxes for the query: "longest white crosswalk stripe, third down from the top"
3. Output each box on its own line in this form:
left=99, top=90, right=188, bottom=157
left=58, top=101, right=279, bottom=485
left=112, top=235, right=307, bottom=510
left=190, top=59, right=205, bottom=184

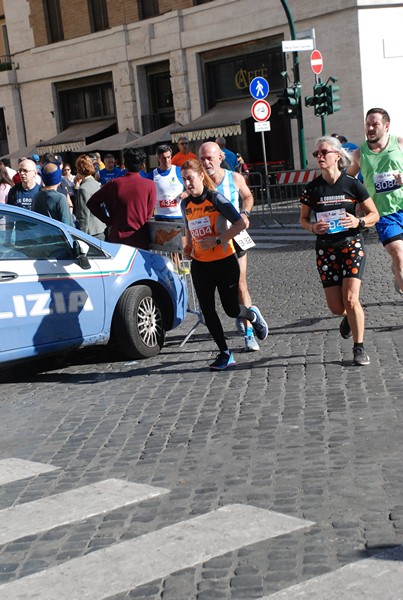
left=0, top=504, right=314, bottom=600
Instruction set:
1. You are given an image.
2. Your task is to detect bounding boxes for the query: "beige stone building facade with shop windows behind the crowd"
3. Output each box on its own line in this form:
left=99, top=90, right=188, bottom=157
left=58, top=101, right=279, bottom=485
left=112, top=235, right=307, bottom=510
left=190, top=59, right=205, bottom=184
left=0, top=0, right=403, bottom=168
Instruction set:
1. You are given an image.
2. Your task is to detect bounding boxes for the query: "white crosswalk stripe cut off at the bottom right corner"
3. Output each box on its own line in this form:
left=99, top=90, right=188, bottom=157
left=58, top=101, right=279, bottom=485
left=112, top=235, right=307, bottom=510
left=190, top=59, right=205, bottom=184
left=264, top=546, right=403, bottom=600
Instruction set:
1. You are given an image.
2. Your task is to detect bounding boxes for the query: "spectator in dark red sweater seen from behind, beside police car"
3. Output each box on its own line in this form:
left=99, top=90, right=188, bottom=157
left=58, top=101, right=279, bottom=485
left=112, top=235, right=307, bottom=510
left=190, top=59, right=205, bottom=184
left=87, top=148, right=156, bottom=250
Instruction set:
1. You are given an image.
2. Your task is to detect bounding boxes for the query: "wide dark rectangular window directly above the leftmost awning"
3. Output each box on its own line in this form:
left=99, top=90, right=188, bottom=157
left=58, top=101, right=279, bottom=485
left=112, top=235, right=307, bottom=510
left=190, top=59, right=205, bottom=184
left=59, top=83, right=116, bottom=128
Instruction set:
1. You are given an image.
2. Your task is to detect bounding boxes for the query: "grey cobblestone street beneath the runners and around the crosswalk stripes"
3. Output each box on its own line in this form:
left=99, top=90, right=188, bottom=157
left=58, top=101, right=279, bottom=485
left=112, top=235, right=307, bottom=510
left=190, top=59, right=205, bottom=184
left=0, top=227, right=403, bottom=600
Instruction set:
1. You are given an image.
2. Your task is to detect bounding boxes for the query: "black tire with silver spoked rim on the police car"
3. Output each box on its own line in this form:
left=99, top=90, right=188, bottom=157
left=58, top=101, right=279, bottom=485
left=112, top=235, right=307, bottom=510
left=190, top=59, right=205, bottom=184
left=113, top=285, right=165, bottom=358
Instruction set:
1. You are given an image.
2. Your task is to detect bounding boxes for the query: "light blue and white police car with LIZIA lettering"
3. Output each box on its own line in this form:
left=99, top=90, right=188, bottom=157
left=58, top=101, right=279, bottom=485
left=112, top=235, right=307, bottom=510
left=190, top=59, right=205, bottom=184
left=0, top=204, right=187, bottom=363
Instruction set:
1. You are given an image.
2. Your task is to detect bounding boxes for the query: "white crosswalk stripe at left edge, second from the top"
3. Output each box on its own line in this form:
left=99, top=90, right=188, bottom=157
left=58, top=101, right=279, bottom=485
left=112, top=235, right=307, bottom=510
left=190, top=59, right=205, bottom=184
left=0, top=479, right=170, bottom=548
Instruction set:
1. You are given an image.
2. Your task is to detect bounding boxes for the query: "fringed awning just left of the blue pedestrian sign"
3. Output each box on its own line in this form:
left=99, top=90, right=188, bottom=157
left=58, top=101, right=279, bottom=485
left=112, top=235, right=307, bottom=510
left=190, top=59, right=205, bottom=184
left=172, top=98, right=253, bottom=142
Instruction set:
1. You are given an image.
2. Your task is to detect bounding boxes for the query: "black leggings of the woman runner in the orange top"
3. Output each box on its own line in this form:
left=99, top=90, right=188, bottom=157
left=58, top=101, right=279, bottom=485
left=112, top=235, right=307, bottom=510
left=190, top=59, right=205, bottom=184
left=191, top=254, right=255, bottom=351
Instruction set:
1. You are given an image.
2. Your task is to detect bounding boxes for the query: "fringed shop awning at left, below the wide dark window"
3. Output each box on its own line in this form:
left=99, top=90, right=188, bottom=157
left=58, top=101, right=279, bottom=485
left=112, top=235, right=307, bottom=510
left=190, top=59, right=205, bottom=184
left=37, top=119, right=116, bottom=155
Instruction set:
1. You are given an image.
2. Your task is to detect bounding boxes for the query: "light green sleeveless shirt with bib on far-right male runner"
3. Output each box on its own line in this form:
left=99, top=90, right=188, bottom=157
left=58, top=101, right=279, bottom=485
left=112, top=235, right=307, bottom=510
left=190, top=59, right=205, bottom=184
left=360, top=135, right=403, bottom=216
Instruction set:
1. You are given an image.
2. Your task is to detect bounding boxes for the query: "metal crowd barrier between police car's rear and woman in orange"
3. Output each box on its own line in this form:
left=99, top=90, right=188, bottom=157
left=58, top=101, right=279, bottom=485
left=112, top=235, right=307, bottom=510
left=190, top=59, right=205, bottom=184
left=148, top=221, right=204, bottom=348
